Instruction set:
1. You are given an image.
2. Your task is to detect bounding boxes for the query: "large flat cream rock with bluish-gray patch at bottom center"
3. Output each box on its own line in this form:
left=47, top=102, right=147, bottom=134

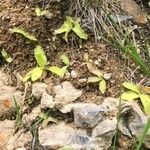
left=39, top=122, right=90, bottom=150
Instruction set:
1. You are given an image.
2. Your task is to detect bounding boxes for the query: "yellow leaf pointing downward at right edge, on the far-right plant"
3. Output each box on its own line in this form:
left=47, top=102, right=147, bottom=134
left=140, top=94, right=150, bottom=115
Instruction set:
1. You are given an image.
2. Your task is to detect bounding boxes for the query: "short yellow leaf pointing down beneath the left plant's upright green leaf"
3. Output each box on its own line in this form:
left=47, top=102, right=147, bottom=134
left=31, top=67, right=43, bottom=82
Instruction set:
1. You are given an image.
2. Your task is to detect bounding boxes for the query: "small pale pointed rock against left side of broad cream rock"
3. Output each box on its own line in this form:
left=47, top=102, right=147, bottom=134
left=41, top=91, right=55, bottom=109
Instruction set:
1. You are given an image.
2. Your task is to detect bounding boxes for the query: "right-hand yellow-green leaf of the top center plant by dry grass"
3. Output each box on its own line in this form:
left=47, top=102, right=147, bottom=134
left=72, top=21, right=88, bottom=40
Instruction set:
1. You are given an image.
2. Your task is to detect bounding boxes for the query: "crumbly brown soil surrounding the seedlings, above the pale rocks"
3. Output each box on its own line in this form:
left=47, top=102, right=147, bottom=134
left=0, top=0, right=149, bottom=150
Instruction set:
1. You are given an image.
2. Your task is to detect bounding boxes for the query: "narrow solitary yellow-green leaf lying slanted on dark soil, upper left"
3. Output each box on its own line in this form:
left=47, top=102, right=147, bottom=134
left=12, top=27, right=37, bottom=41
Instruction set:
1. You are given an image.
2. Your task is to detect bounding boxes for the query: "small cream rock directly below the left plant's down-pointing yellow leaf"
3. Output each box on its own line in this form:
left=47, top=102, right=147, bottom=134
left=32, top=82, right=48, bottom=99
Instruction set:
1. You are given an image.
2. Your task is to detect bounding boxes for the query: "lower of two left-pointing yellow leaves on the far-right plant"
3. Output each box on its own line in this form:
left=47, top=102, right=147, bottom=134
left=120, top=91, right=139, bottom=101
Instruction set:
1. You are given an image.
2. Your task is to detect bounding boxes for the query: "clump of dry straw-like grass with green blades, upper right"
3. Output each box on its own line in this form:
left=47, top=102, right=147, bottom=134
left=70, top=0, right=150, bottom=76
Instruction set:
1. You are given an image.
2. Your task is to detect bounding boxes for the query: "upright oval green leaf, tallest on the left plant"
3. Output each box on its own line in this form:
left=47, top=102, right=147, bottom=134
left=34, top=45, right=47, bottom=67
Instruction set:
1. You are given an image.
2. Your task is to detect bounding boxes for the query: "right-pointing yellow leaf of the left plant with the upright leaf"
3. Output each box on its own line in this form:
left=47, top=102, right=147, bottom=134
left=48, top=66, right=68, bottom=78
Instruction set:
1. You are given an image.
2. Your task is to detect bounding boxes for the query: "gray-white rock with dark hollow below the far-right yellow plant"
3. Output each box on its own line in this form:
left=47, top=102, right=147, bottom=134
left=119, top=101, right=148, bottom=137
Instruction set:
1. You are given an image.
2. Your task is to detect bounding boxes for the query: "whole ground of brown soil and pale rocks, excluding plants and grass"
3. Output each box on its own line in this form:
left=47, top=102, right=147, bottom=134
left=0, top=0, right=150, bottom=150
